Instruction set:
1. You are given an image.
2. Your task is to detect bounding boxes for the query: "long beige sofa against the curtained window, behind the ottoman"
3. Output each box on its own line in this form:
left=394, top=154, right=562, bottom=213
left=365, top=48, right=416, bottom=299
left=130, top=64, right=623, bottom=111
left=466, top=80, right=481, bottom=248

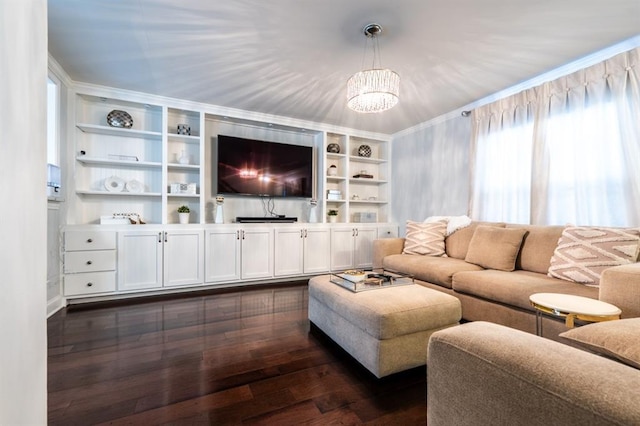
left=374, top=222, right=640, bottom=339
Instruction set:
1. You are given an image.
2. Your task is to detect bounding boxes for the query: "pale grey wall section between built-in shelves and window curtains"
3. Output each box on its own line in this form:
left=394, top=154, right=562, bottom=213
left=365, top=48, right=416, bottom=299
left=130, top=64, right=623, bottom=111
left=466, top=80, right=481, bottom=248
left=391, top=116, right=471, bottom=235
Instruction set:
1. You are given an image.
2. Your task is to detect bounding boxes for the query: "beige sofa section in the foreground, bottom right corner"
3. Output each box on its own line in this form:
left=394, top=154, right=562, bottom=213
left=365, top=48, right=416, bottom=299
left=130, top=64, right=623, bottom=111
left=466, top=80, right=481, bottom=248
left=427, top=318, right=640, bottom=426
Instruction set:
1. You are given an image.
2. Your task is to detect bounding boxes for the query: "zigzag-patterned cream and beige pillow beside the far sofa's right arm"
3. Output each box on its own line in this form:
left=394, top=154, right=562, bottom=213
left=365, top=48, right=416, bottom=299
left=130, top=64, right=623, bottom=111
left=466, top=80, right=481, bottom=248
left=547, top=226, right=640, bottom=287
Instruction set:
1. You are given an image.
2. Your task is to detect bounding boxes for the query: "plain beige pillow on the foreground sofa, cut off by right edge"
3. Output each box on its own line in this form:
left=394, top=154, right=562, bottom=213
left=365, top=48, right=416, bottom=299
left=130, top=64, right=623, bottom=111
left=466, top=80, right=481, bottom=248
left=560, top=318, right=640, bottom=369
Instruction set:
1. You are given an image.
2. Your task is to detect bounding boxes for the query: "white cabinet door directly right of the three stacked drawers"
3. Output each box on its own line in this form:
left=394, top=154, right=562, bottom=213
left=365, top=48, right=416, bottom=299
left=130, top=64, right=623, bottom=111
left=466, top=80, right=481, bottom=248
left=118, top=230, right=162, bottom=291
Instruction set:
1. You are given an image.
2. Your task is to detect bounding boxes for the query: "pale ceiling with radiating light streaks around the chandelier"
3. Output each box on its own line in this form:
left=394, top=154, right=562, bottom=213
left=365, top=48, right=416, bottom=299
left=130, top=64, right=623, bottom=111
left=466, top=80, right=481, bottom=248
left=48, top=0, right=640, bottom=134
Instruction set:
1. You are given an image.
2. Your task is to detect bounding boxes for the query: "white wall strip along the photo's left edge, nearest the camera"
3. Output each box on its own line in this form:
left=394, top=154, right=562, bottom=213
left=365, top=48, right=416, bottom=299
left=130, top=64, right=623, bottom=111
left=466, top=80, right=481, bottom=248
left=0, top=0, right=47, bottom=425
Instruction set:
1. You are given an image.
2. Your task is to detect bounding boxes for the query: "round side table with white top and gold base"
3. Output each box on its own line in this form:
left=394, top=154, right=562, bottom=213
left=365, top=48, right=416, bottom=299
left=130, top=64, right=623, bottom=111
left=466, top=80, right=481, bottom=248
left=529, top=293, right=622, bottom=336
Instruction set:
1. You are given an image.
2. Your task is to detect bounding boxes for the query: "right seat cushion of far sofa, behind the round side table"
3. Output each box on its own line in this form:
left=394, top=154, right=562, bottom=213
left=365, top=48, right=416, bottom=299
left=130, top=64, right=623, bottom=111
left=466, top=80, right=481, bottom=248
left=452, top=269, right=598, bottom=311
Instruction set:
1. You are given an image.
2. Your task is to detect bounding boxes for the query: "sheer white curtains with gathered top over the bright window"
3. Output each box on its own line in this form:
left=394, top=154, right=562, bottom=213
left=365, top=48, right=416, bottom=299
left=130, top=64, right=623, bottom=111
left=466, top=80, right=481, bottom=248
left=471, top=49, right=640, bottom=226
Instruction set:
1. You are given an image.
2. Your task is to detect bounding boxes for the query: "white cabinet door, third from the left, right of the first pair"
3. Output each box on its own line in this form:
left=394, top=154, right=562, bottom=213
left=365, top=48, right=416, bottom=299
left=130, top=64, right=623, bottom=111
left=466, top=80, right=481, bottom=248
left=204, top=227, right=241, bottom=283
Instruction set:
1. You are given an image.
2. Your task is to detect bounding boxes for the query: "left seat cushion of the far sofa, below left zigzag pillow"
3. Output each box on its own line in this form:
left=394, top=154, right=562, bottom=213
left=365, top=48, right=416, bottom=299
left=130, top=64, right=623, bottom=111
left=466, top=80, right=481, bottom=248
left=382, top=254, right=482, bottom=288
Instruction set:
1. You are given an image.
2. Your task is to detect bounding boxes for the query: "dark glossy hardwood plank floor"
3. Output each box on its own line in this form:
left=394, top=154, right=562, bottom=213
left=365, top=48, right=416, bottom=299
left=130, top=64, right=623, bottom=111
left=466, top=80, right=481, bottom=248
left=48, top=283, right=426, bottom=425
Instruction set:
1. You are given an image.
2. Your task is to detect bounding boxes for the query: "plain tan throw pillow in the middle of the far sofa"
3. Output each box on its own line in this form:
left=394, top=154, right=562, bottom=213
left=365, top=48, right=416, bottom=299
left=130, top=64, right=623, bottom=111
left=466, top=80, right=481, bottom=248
left=464, top=226, right=527, bottom=271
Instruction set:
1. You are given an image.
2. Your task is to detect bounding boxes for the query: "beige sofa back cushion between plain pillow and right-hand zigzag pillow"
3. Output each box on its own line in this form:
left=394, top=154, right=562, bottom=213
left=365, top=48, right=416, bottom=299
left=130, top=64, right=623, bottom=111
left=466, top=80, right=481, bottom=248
left=507, top=224, right=564, bottom=274
